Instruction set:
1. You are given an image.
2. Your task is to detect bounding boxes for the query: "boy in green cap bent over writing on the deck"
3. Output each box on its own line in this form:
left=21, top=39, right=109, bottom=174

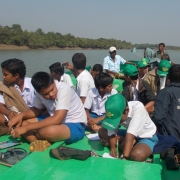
left=98, top=94, right=158, bottom=161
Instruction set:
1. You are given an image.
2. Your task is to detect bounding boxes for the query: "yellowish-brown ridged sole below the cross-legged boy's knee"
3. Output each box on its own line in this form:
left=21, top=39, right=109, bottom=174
left=29, top=140, right=51, bottom=152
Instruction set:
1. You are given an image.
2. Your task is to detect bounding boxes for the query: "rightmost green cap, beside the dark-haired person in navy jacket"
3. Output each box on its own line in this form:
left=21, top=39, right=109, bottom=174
left=158, top=60, right=171, bottom=76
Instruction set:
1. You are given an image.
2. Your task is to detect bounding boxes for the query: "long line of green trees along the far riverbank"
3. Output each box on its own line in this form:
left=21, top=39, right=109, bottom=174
left=0, top=24, right=180, bottom=50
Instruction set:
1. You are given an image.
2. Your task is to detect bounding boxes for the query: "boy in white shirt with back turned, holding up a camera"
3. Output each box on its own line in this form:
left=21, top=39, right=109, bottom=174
left=66, top=53, right=95, bottom=103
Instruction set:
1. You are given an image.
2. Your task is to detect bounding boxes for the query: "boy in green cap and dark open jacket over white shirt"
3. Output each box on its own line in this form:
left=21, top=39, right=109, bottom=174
left=122, top=64, right=156, bottom=114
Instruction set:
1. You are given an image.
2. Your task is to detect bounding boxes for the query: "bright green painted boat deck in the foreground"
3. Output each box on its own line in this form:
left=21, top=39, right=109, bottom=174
left=0, top=136, right=180, bottom=180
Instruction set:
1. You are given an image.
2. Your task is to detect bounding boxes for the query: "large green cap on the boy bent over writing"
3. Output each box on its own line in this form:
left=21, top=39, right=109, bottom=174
left=102, top=93, right=126, bottom=130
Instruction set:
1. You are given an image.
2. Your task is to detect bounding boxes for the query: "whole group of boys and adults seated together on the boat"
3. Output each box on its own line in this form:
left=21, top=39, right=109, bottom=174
left=0, top=44, right=180, bottom=169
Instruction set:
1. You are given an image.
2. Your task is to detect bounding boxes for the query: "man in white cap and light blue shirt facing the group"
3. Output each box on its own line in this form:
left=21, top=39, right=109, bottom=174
left=103, top=47, right=132, bottom=79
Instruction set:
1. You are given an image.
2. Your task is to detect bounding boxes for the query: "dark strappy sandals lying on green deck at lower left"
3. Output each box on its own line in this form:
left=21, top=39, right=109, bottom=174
left=0, top=148, right=28, bottom=167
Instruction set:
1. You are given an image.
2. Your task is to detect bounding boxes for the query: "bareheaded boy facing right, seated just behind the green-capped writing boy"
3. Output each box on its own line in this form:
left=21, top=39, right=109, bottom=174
left=84, top=72, right=117, bottom=131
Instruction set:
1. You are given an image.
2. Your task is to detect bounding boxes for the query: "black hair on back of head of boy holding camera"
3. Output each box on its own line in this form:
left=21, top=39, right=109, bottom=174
left=72, top=53, right=86, bottom=70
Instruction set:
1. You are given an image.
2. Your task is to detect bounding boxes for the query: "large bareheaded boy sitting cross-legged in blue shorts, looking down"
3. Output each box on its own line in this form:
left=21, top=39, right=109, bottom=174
left=8, top=72, right=87, bottom=149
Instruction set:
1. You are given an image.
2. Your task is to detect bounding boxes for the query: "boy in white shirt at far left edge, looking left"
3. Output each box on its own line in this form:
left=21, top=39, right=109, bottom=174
left=0, top=59, right=36, bottom=134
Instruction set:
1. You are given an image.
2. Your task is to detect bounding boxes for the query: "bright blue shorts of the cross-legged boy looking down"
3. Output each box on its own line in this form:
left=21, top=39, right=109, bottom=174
left=63, top=123, right=85, bottom=144
